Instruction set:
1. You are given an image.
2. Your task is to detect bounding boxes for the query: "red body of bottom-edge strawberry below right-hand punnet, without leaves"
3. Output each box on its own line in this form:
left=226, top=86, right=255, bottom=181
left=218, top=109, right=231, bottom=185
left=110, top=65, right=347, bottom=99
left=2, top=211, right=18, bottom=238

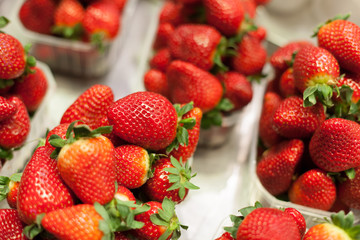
left=236, top=208, right=301, bottom=240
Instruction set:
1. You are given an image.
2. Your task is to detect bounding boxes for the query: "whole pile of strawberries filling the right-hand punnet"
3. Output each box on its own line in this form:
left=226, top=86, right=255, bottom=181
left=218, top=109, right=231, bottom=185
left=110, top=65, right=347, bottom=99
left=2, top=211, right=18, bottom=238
left=256, top=16, right=360, bottom=211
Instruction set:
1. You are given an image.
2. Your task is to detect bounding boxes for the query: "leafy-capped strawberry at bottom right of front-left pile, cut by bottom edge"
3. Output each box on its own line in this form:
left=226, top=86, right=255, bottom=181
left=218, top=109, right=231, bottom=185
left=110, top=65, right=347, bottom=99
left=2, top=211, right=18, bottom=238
left=134, top=198, right=186, bottom=240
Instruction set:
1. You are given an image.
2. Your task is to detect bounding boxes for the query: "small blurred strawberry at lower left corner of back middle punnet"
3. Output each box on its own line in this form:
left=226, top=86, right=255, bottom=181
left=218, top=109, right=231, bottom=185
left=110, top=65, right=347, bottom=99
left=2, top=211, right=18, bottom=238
left=144, top=69, right=170, bottom=98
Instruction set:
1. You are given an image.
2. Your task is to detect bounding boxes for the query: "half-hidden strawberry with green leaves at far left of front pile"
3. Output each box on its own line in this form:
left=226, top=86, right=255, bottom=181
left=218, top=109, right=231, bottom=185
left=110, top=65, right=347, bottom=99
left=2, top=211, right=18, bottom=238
left=0, top=173, right=22, bottom=209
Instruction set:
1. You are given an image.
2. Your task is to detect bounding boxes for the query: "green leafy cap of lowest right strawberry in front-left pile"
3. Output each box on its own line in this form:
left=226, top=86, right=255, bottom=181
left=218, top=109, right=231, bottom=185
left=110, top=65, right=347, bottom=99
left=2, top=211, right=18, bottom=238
left=150, top=198, right=188, bottom=240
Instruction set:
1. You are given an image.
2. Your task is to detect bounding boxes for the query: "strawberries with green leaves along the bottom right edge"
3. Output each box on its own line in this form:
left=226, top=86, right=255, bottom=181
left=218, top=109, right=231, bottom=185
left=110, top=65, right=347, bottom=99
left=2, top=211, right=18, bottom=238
left=215, top=202, right=360, bottom=240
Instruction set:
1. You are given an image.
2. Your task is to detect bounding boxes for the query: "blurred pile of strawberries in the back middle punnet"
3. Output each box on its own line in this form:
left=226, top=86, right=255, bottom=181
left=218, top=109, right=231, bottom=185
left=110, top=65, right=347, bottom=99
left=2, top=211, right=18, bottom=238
left=144, top=0, right=268, bottom=129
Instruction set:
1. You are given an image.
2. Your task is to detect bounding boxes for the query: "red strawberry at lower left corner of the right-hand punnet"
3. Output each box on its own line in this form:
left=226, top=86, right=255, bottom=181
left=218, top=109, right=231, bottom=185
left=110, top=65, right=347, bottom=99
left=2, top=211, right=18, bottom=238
left=256, top=139, right=304, bottom=195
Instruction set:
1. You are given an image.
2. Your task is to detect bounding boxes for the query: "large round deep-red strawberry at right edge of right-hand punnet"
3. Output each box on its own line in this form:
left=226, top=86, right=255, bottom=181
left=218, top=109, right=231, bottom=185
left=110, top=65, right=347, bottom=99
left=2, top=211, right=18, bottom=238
left=309, top=118, right=360, bottom=172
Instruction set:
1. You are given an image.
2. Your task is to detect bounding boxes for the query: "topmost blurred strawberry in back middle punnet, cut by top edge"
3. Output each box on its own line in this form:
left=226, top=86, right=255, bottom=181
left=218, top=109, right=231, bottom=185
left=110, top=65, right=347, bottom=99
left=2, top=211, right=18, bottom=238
left=203, top=0, right=245, bottom=36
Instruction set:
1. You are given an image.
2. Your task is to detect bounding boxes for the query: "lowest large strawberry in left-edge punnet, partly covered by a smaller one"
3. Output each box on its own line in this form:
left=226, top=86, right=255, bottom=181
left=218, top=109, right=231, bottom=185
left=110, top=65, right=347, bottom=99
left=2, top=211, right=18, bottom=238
left=0, top=97, right=30, bottom=149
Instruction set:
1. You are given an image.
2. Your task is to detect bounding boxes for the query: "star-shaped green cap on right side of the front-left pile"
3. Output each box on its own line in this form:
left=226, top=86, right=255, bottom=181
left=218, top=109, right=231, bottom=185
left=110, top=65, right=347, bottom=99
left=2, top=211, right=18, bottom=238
left=164, top=156, right=200, bottom=199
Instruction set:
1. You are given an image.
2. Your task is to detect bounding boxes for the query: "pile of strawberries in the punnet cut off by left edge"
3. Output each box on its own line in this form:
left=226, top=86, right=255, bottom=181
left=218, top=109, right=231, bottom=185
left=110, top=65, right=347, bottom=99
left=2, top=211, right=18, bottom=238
left=0, top=17, right=48, bottom=169
